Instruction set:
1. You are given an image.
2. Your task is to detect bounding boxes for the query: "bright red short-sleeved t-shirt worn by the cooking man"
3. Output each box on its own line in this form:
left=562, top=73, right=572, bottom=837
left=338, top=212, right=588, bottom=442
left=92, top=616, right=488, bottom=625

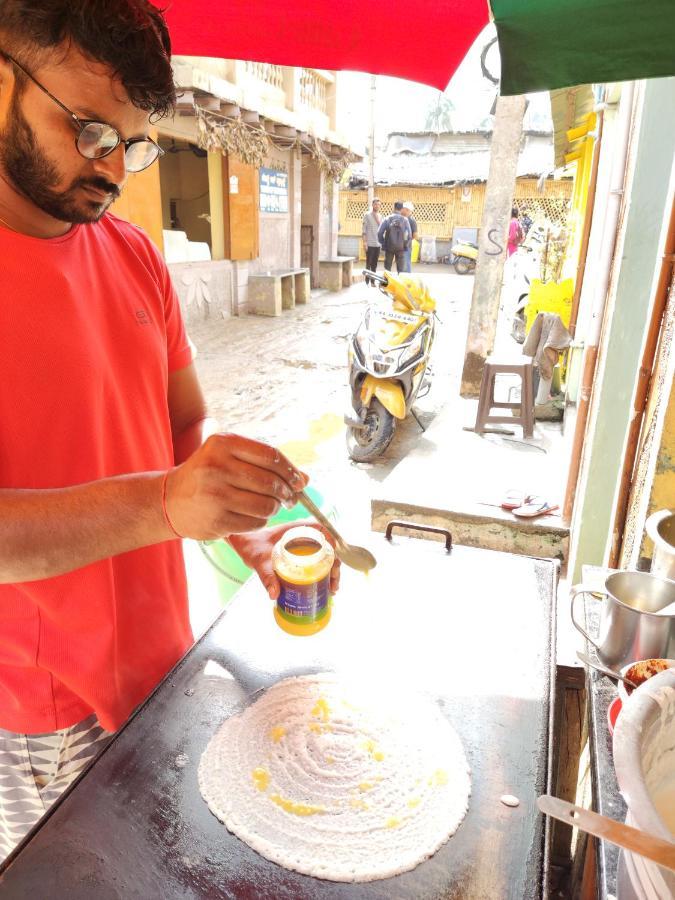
left=0, top=215, right=192, bottom=734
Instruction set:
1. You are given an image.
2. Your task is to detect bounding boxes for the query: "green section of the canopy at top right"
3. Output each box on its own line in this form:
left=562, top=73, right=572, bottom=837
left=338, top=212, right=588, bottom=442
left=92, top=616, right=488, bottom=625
left=491, top=0, right=675, bottom=95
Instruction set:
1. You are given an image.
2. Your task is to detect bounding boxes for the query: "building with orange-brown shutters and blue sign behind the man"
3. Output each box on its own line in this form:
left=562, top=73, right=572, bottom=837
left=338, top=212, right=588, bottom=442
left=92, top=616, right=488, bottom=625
left=114, top=57, right=356, bottom=322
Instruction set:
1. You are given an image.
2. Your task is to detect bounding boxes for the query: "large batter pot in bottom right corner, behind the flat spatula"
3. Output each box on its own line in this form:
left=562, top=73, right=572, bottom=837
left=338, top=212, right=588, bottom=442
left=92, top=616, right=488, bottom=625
left=613, top=669, right=675, bottom=900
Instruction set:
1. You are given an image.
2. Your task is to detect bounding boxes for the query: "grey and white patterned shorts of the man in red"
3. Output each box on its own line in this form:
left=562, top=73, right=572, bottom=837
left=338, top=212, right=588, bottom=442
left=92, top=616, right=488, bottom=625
left=0, top=715, right=112, bottom=862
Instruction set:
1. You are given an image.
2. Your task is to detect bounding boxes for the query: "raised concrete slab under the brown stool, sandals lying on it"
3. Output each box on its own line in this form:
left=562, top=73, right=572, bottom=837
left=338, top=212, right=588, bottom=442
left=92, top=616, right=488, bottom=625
left=371, top=399, right=569, bottom=565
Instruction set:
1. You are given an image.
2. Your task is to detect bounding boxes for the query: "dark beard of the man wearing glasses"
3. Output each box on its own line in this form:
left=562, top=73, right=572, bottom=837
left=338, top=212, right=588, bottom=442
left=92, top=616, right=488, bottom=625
left=0, top=90, right=121, bottom=225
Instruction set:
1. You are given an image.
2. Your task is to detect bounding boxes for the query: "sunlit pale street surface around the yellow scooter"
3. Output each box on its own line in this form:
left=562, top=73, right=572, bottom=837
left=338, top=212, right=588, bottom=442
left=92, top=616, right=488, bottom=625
left=185, top=266, right=473, bottom=633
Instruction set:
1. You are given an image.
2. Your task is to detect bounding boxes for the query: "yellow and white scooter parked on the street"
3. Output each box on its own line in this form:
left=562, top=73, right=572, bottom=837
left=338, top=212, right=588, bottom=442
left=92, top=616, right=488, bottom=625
left=345, top=270, right=436, bottom=462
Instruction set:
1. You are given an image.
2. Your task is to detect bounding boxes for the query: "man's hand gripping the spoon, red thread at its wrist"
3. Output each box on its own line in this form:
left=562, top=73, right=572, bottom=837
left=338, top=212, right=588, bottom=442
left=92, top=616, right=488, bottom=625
left=166, top=434, right=308, bottom=540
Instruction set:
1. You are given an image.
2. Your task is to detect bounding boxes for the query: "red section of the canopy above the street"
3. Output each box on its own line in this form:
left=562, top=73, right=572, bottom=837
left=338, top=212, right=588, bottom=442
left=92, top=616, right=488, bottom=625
left=153, top=0, right=488, bottom=91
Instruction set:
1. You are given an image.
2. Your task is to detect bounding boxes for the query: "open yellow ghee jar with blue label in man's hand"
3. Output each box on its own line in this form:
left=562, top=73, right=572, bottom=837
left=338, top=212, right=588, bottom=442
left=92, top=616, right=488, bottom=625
left=272, top=525, right=335, bottom=635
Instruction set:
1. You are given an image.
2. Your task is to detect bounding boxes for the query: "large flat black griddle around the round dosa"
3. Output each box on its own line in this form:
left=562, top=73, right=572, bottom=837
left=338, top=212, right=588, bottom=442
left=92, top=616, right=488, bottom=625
left=0, top=535, right=557, bottom=900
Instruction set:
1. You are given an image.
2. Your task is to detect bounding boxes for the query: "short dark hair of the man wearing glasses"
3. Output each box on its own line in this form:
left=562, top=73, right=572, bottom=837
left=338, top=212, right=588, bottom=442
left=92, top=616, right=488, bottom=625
left=0, top=0, right=176, bottom=118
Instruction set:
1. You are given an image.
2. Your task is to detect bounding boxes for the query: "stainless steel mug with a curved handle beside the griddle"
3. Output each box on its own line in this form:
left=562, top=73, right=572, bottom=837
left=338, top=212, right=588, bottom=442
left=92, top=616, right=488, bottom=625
left=571, top=572, right=675, bottom=669
